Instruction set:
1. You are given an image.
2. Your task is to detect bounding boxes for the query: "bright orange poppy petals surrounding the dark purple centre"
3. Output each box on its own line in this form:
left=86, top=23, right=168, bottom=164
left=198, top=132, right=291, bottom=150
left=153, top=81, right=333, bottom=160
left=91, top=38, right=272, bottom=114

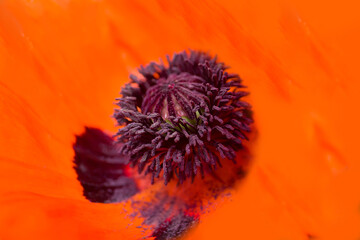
left=0, top=0, right=360, bottom=239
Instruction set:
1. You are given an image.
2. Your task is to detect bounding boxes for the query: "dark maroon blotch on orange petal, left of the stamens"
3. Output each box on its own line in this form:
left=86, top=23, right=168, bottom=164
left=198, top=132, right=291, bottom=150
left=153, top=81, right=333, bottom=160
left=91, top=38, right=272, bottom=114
left=73, top=128, right=138, bottom=203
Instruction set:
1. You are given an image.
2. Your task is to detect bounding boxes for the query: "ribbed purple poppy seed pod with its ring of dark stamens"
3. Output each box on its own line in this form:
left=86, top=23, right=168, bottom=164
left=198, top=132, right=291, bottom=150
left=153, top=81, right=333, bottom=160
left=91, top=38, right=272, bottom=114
left=114, top=51, right=253, bottom=184
